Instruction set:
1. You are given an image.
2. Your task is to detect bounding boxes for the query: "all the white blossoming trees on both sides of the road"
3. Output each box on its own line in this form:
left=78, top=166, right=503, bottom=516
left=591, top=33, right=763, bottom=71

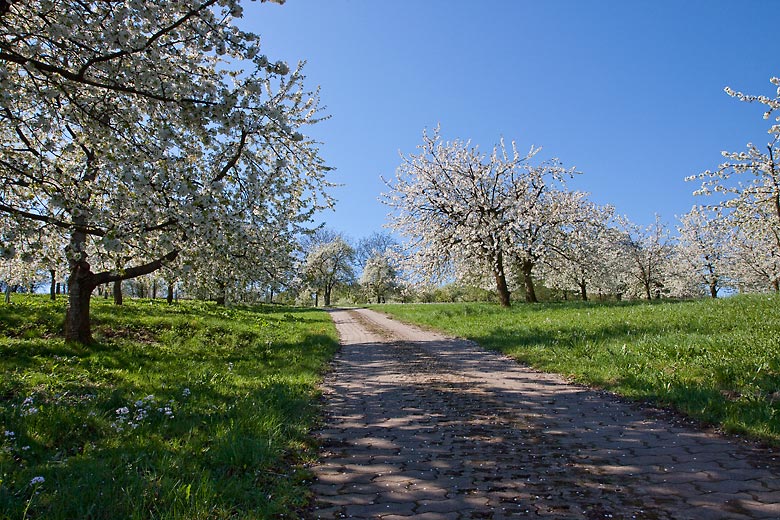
left=0, top=0, right=780, bottom=342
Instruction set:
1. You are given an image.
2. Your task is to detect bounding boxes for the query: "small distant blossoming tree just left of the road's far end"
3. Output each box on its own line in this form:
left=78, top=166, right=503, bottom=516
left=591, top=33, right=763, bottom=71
left=303, top=235, right=355, bottom=306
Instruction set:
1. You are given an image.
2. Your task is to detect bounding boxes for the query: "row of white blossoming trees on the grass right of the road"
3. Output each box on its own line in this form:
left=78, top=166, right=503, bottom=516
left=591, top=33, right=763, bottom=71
left=384, top=78, right=780, bottom=306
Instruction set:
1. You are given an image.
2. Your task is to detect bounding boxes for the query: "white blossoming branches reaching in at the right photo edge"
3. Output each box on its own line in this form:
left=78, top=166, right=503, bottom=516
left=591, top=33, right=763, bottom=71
left=686, top=78, right=780, bottom=264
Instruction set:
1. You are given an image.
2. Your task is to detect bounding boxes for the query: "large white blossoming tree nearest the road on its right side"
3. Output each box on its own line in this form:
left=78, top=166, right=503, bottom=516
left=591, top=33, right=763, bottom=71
left=382, top=129, right=573, bottom=306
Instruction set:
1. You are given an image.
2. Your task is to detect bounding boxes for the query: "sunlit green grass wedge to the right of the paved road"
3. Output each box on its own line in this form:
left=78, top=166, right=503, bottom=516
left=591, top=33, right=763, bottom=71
left=375, top=295, right=780, bottom=446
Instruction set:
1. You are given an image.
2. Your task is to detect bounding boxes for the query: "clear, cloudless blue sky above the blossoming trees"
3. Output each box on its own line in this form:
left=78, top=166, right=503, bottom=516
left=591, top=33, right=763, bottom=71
left=239, top=0, right=780, bottom=243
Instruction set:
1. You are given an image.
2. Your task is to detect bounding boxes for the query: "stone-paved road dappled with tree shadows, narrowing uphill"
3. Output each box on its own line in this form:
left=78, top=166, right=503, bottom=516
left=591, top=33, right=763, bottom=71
left=311, top=310, right=780, bottom=520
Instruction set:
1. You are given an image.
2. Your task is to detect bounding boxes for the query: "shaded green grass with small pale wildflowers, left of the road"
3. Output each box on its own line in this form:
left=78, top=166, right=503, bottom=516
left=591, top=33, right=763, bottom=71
left=0, top=295, right=337, bottom=519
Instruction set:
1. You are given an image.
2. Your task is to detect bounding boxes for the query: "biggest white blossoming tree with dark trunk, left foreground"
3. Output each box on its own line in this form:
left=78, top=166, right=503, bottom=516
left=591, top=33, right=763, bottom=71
left=0, top=0, right=330, bottom=342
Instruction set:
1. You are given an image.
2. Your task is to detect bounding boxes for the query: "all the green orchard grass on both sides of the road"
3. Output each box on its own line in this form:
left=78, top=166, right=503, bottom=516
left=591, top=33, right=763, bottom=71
left=0, top=295, right=780, bottom=519
